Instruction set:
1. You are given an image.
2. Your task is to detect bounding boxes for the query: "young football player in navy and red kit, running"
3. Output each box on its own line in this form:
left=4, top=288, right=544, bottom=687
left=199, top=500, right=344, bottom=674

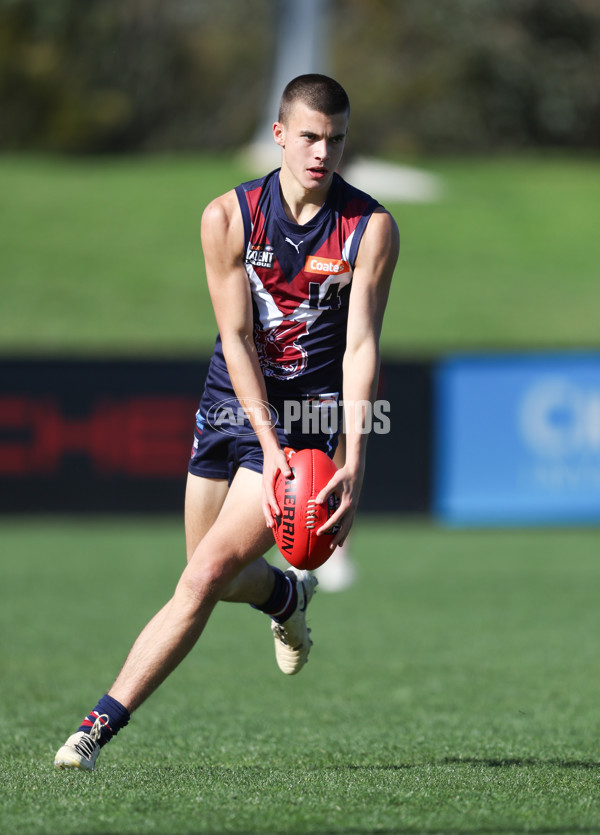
left=55, top=74, right=399, bottom=770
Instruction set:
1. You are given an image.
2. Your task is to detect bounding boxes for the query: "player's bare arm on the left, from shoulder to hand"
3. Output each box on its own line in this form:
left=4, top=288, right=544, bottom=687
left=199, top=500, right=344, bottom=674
left=201, top=191, right=291, bottom=527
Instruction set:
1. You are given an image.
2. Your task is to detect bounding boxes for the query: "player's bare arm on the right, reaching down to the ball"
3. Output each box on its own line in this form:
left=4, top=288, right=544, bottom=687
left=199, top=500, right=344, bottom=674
left=317, top=209, right=400, bottom=547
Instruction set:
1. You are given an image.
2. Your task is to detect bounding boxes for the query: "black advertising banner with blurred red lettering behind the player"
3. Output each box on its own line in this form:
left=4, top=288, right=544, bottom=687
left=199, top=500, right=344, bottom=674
left=0, top=358, right=432, bottom=515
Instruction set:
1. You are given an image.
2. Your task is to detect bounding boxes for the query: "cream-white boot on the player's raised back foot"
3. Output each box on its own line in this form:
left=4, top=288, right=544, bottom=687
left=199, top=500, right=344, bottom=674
left=271, top=569, right=318, bottom=676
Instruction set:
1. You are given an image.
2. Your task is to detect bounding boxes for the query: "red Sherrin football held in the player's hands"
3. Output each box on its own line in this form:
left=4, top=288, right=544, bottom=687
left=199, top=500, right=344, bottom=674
left=273, top=449, right=339, bottom=571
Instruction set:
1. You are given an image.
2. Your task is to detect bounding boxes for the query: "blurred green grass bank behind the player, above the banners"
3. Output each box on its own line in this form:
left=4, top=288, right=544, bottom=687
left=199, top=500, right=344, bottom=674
left=0, top=155, right=600, bottom=356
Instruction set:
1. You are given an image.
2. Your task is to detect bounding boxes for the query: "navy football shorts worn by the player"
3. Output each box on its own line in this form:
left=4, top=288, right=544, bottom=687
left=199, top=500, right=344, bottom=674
left=188, top=391, right=338, bottom=484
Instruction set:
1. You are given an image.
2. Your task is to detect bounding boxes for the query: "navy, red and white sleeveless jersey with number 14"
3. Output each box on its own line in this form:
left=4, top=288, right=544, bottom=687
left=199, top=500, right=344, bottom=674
left=202, top=169, right=379, bottom=401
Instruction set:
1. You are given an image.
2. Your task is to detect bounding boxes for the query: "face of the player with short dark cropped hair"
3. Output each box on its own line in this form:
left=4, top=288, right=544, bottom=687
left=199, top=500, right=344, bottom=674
left=273, top=101, right=348, bottom=191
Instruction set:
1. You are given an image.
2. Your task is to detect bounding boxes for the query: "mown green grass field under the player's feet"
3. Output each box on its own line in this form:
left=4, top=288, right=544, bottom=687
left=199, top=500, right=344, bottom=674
left=0, top=519, right=600, bottom=835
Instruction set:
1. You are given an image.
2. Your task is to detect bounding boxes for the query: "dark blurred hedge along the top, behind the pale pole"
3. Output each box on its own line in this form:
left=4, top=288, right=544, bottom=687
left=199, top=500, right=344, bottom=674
left=0, top=0, right=600, bottom=156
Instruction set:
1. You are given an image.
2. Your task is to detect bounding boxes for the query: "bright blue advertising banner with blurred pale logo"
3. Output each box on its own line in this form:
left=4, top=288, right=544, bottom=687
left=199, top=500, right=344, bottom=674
left=434, top=353, right=600, bottom=525
